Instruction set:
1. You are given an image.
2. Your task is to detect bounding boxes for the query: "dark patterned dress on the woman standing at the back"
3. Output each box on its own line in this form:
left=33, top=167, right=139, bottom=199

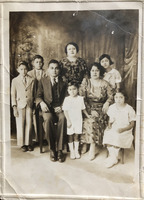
left=60, top=57, right=88, bottom=83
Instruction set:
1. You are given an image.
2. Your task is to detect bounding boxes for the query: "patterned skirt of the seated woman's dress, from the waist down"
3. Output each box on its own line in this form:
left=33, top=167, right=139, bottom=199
left=81, top=102, right=108, bottom=145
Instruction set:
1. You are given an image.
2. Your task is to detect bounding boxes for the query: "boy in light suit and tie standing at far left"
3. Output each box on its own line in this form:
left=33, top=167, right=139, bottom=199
left=11, top=61, right=36, bottom=152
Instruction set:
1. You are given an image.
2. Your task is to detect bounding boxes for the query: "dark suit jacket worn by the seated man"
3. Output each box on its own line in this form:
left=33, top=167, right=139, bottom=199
left=36, top=76, right=67, bottom=109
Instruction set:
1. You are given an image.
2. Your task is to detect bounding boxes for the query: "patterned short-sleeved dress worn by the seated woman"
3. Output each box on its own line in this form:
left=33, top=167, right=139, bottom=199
left=79, top=78, right=113, bottom=145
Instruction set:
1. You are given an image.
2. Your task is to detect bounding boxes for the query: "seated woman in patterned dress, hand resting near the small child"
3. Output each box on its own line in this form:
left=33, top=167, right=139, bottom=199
left=79, top=62, right=113, bottom=160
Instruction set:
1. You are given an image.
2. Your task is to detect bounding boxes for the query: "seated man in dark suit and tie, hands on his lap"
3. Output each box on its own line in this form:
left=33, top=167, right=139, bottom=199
left=36, top=60, right=67, bottom=162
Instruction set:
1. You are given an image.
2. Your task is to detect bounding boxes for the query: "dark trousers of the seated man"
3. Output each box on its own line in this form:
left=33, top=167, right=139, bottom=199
left=42, top=112, right=66, bottom=151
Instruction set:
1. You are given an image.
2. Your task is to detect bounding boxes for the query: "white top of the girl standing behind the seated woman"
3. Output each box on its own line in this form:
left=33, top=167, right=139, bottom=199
left=103, top=69, right=122, bottom=88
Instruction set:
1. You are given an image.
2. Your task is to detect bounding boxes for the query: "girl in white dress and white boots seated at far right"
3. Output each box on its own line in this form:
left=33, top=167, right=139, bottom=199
left=103, top=90, right=136, bottom=167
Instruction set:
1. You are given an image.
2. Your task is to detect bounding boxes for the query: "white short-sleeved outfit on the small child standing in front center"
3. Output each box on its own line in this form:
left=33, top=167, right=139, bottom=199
left=62, top=95, right=85, bottom=135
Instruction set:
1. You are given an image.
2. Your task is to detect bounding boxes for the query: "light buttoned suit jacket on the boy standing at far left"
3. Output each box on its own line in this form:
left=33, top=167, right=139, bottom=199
left=11, top=75, right=36, bottom=109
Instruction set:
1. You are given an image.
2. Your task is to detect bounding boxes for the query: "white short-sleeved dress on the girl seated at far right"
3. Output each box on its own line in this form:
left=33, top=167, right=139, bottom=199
left=103, top=103, right=136, bottom=148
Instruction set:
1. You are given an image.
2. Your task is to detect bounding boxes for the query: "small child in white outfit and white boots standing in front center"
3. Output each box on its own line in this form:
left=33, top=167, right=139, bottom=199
left=63, top=81, right=90, bottom=159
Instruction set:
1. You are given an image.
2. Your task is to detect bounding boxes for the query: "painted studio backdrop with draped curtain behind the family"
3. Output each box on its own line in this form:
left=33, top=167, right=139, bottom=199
left=9, top=10, right=138, bottom=136
